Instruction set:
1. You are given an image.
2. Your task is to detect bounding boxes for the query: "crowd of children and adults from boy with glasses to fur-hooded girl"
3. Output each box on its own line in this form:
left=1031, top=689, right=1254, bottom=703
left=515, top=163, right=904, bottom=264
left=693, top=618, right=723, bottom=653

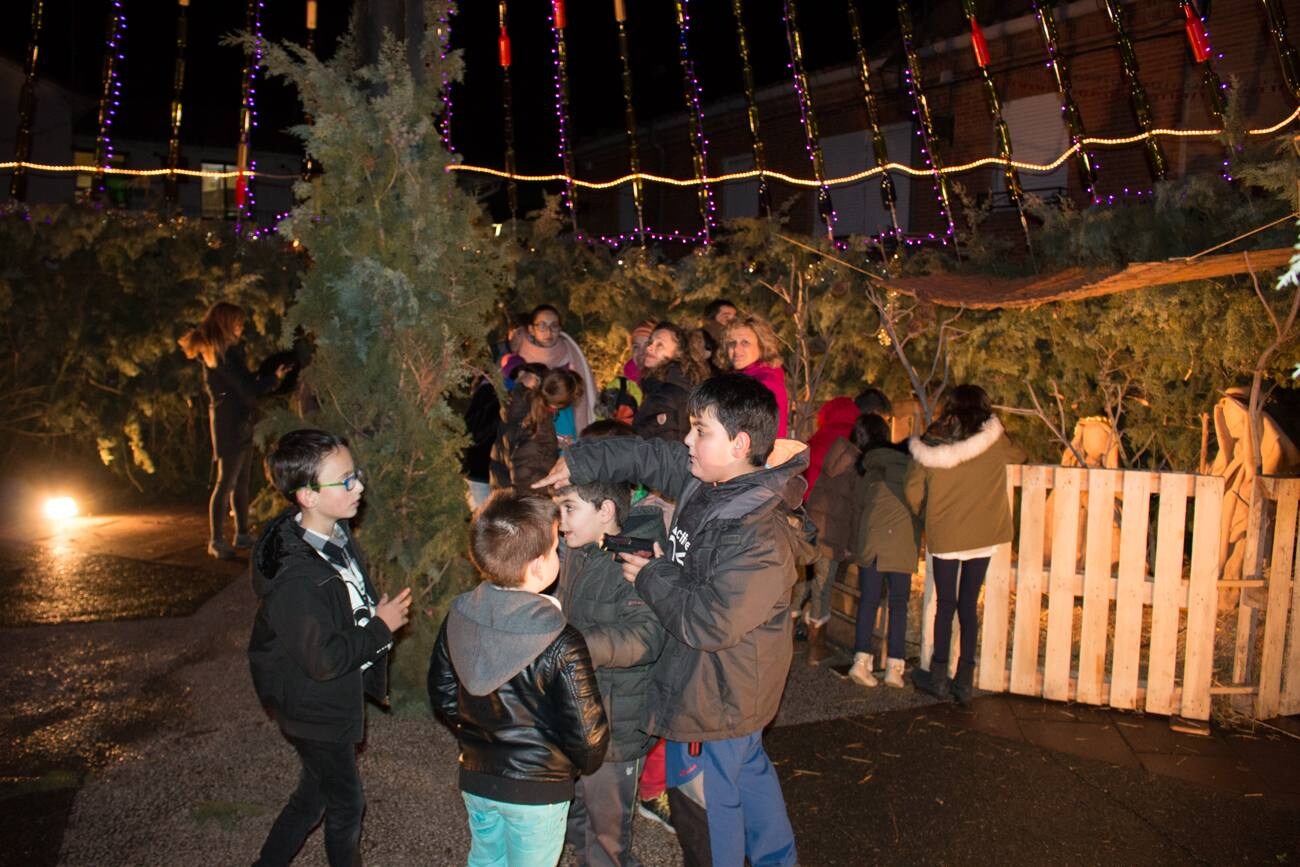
left=241, top=300, right=1023, bottom=867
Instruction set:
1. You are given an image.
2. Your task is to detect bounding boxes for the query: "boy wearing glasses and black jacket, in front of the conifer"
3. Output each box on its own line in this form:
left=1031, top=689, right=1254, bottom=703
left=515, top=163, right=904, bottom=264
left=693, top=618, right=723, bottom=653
left=248, top=430, right=411, bottom=867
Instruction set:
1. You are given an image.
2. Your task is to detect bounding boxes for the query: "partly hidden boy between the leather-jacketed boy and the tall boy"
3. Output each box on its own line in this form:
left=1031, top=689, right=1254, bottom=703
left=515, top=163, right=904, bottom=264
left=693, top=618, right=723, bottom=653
left=554, top=482, right=667, bottom=867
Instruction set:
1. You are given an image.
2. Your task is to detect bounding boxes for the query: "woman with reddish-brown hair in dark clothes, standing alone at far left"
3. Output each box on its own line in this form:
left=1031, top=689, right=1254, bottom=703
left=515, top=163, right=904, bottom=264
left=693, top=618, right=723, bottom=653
left=177, top=302, right=291, bottom=560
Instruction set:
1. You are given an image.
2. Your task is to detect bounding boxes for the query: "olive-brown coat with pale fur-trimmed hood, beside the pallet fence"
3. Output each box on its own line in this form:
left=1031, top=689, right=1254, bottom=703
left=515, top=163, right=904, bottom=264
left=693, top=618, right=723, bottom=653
left=906, top=416, right=1024, bottom=556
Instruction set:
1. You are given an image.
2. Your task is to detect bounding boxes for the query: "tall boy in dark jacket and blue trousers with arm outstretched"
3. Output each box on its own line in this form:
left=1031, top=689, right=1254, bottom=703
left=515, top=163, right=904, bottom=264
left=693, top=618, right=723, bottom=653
left=538, top=373, right=811, bottom=867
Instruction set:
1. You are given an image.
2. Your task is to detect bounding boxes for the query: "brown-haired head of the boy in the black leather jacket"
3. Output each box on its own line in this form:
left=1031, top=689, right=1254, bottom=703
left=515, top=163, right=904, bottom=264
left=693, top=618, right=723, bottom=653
left=469, top=487, right=559, bottom=588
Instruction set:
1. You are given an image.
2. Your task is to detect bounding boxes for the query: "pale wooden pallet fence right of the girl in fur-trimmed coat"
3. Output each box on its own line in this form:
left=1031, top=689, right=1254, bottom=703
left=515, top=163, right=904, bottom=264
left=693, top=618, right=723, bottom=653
left=835, top=465, right=1227, bottom=720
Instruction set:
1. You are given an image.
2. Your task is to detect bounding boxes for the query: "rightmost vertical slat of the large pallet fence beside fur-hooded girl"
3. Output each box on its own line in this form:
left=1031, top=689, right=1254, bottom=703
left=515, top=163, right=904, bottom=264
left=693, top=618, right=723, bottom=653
left=1145, top=473, right=1190, bottom=716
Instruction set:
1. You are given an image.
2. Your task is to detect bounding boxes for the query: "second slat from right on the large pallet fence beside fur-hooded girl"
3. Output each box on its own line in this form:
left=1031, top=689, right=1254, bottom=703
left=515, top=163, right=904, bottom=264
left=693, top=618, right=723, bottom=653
left=1110, top=473, right=1151, bottom=710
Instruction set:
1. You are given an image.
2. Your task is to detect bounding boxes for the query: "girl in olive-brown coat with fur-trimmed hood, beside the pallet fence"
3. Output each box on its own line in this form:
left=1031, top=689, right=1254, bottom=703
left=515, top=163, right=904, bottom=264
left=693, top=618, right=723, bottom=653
left=905, top=385, right=1024, bottom=705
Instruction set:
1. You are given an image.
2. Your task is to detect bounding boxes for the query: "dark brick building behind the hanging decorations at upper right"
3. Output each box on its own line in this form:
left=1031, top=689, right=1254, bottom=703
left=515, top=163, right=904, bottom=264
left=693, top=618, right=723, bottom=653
left=575, top=0, right=1300, bottom=246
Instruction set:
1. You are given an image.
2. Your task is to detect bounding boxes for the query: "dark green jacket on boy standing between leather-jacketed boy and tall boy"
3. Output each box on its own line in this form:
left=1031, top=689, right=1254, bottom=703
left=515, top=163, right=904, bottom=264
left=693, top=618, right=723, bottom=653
left=555, top=507, right=667, bottom=762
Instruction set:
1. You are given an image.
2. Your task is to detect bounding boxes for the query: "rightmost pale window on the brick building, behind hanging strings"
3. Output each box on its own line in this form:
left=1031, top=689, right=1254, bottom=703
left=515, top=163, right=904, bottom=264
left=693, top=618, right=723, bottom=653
left=992, top=92, right=1070, bottom=208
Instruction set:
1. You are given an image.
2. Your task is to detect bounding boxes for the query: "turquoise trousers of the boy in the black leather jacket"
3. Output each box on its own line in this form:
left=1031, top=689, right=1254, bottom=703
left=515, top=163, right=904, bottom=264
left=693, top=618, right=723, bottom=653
left=460, top=792, right=569, bottom=867
